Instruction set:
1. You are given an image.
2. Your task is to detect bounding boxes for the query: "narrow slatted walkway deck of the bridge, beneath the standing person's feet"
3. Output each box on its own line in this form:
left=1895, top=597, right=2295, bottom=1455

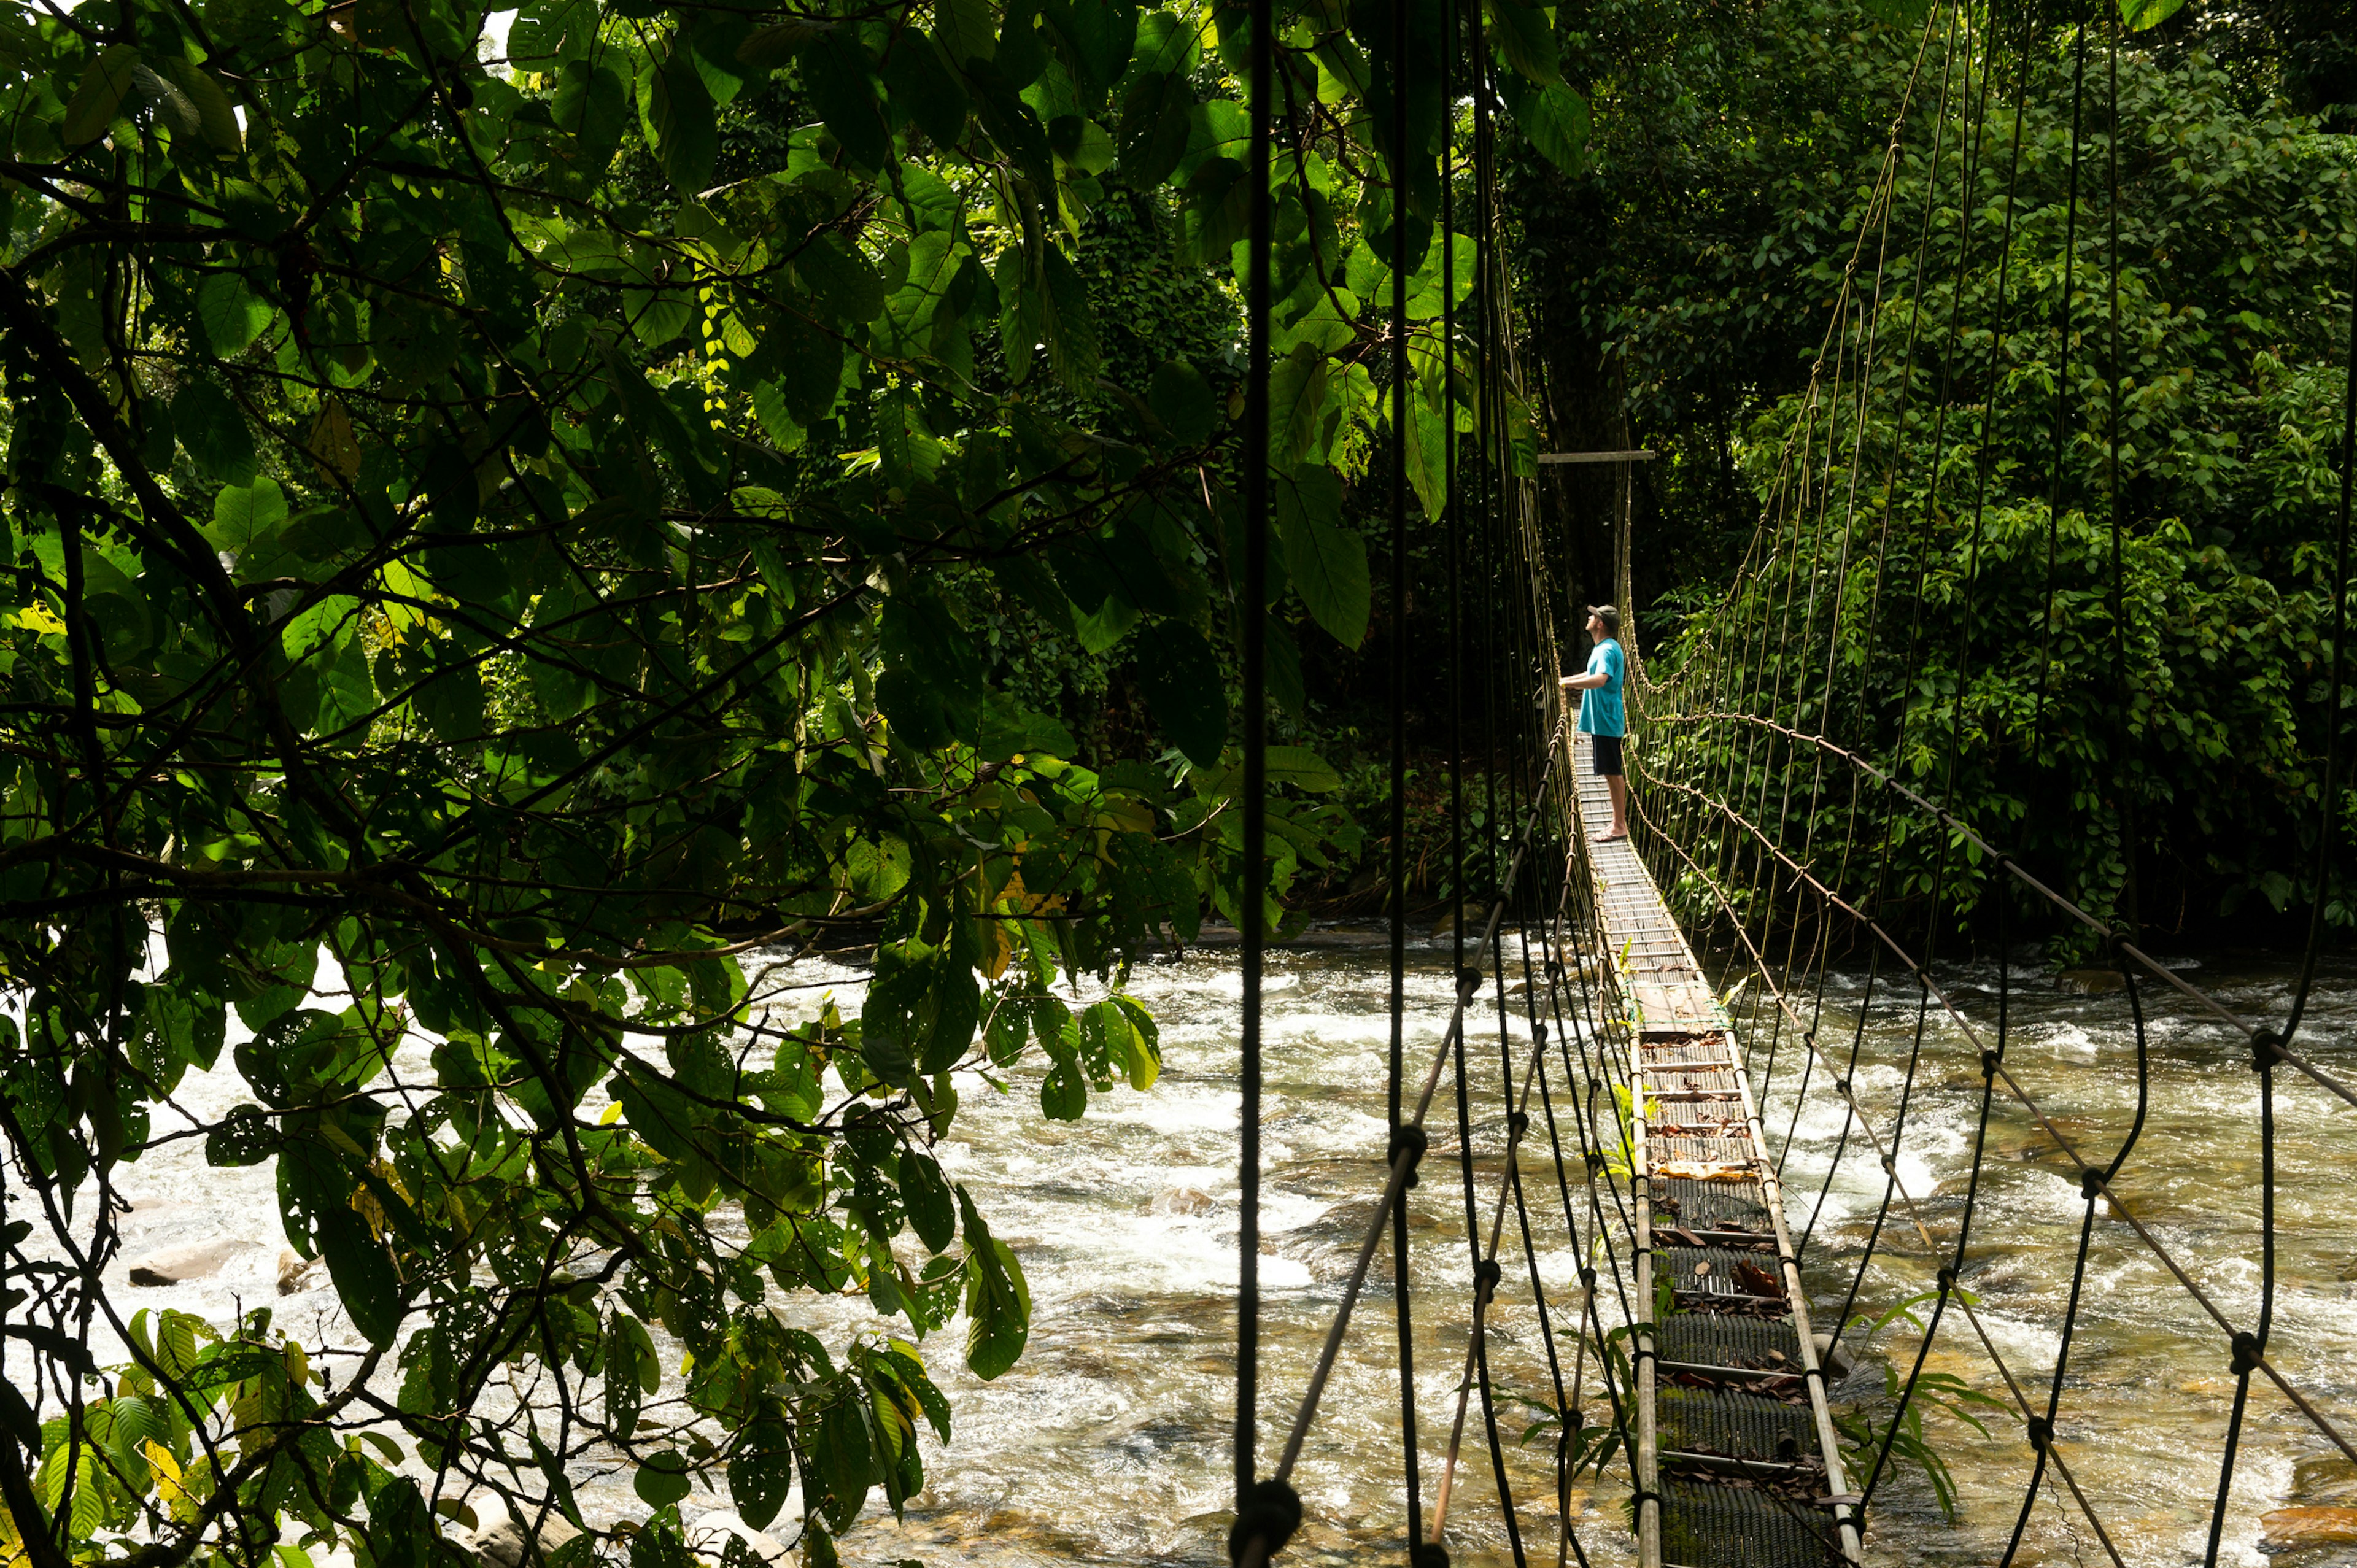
left=1572, top=736, right=1857, bottom=1568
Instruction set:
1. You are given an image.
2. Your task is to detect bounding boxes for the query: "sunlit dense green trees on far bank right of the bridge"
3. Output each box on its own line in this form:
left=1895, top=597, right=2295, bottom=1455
left=1525, top=2, right=2357, bottom=932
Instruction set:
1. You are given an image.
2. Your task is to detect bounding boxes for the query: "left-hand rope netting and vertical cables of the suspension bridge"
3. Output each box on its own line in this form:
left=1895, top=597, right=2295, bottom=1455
left=1228, top=5, right=1643, bottom=1566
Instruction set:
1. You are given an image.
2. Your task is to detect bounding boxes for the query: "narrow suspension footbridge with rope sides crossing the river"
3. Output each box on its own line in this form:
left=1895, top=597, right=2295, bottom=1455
left=1228, top=0, right=2357, bottom=1568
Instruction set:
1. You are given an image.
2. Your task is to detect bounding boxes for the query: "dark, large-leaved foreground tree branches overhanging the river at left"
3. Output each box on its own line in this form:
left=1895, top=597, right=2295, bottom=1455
left=0, top=0, right=1584, bottom=1568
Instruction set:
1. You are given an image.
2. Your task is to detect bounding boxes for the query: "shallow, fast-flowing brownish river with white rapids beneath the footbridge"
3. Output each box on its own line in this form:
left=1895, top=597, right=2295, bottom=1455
left=50, top=943, right=2357, bottom=1568
